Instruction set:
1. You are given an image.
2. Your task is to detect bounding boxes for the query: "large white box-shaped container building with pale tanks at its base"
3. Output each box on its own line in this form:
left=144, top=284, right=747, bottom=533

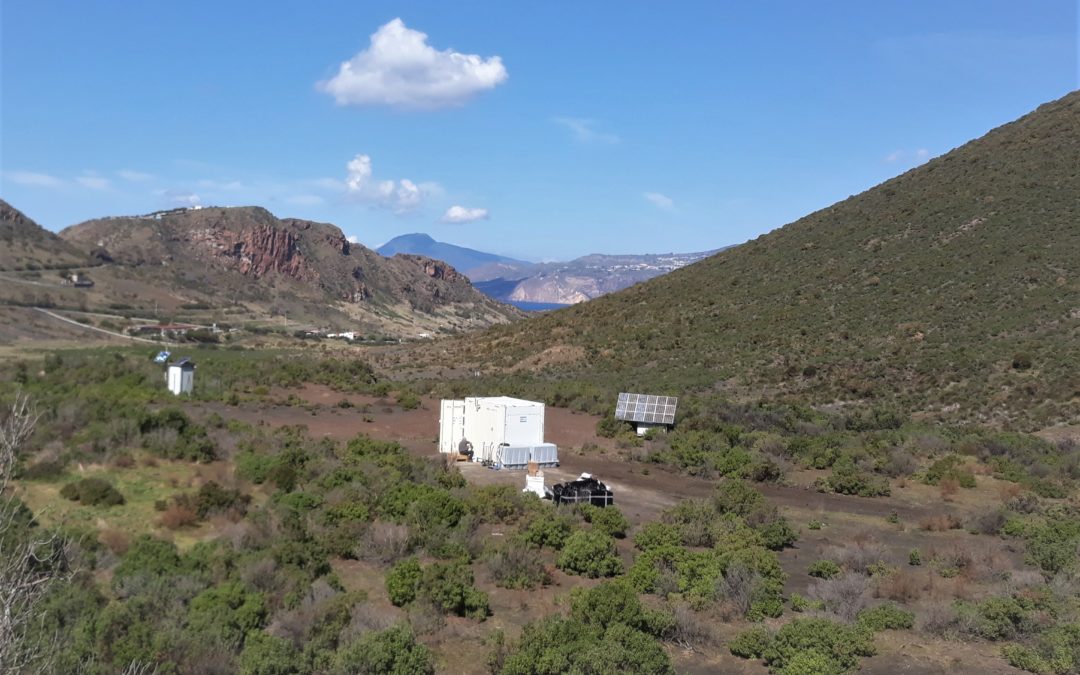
left=438, top=396, right=558, bottom=469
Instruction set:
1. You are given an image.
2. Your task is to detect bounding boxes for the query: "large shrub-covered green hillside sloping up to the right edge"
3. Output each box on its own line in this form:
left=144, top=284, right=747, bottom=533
left=436, top=93, right=1080, bottom=428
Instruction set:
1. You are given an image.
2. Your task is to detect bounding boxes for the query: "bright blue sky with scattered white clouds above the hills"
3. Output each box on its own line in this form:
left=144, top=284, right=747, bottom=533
left=0, top=0, right=1078, bottom=259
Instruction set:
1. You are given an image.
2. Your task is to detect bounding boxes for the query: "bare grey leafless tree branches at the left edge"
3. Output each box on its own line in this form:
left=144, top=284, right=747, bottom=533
left=0, top=393, right=68, bottom=674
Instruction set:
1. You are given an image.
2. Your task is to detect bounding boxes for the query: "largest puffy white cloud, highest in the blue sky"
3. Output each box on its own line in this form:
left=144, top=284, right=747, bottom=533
left=315, top=18, right=509, bottom=109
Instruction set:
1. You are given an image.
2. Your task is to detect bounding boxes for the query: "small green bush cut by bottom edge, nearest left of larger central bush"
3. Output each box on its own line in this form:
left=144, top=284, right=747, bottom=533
left=330, top=624, right=435, bottom=675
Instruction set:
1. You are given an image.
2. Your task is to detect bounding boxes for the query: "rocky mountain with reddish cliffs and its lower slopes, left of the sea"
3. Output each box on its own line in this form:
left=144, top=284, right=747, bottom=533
left=26, top=206, right=519, bottom=335
